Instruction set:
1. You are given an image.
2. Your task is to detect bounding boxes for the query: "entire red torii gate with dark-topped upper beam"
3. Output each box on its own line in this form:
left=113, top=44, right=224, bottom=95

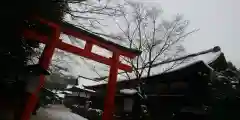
left=21, top=18, right=141, bottom=120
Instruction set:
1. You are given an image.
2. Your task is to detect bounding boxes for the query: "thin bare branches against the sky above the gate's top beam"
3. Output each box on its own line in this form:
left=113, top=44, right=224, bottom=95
left=64, top=0, right=121, bottom=33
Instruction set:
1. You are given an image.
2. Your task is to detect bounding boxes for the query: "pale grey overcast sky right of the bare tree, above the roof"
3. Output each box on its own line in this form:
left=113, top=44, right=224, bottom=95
left=139, top=0, right=240, bottom=67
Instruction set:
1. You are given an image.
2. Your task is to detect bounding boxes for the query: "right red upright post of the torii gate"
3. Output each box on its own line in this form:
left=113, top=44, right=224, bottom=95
left=102, top=53, right=119, bottom=120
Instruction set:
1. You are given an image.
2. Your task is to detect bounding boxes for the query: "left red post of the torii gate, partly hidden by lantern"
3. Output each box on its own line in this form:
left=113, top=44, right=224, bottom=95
left=21, top=26, right=60, bottom=120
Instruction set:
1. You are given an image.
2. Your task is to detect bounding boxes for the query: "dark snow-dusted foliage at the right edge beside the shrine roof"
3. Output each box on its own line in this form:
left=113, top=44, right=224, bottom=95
left=208, top=62, right=240, bottom=120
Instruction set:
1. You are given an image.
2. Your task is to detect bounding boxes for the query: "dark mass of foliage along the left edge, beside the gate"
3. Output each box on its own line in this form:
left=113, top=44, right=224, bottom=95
left=0, top=0, right=71, bottom=119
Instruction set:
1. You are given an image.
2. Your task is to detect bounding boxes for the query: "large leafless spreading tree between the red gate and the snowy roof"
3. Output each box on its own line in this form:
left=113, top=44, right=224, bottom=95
left=99, top=2, right=197, bottom=79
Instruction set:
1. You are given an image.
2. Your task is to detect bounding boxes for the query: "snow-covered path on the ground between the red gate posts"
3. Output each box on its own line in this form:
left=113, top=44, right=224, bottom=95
left=31, top=105, right=87, bottom=120
